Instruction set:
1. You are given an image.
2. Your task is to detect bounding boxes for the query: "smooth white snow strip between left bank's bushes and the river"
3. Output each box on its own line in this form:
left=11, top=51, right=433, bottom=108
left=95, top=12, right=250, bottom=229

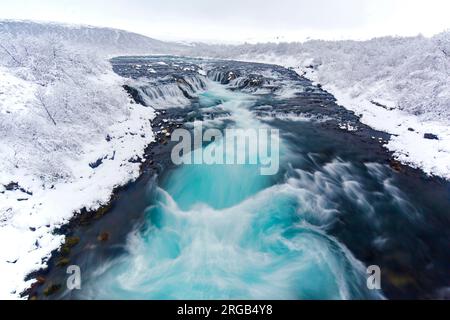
left=0, top=94, right=153, bottom=298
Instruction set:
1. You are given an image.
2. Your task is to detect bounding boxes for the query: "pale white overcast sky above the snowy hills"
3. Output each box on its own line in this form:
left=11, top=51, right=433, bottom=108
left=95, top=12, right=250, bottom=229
left=0, top=0, right=450, bottom=42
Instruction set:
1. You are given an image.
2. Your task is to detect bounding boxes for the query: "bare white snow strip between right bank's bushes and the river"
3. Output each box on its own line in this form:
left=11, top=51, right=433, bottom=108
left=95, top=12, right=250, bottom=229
left=272, top=56, right=450, bottom=180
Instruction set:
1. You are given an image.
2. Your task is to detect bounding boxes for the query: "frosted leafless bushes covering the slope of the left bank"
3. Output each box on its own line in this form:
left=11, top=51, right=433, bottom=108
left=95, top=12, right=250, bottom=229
left=0, top=34, right=129, bottom=183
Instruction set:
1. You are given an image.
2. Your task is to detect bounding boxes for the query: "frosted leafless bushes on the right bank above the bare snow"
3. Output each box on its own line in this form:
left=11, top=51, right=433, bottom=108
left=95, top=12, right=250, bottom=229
left=192, top=32, right=450, bottom=123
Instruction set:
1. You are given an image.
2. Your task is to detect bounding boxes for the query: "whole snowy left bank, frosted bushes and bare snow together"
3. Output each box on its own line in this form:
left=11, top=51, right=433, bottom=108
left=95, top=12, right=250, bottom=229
left=0, top=21, right=155, bottom=299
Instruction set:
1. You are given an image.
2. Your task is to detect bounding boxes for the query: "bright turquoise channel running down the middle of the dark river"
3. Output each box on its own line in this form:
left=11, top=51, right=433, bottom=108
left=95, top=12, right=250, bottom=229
left=82, top=80, right=382, bottom=299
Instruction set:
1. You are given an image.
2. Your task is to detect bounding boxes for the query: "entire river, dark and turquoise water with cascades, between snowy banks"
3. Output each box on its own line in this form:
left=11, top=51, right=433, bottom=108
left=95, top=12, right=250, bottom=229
left=31, top=57, right=450, bottom=299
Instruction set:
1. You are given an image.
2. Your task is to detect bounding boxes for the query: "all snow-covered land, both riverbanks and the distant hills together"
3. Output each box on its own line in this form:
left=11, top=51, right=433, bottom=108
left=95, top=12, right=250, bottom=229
left=0, top=21, right=450, bottom=299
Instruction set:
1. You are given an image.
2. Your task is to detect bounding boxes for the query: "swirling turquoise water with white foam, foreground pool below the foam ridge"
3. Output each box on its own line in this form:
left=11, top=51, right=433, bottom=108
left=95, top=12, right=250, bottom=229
left=81, top=185, right=377, bottom=299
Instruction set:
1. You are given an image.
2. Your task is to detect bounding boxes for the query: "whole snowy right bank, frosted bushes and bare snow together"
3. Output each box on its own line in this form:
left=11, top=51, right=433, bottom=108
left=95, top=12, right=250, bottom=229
left=192, top=32, right=450, bottom=179
